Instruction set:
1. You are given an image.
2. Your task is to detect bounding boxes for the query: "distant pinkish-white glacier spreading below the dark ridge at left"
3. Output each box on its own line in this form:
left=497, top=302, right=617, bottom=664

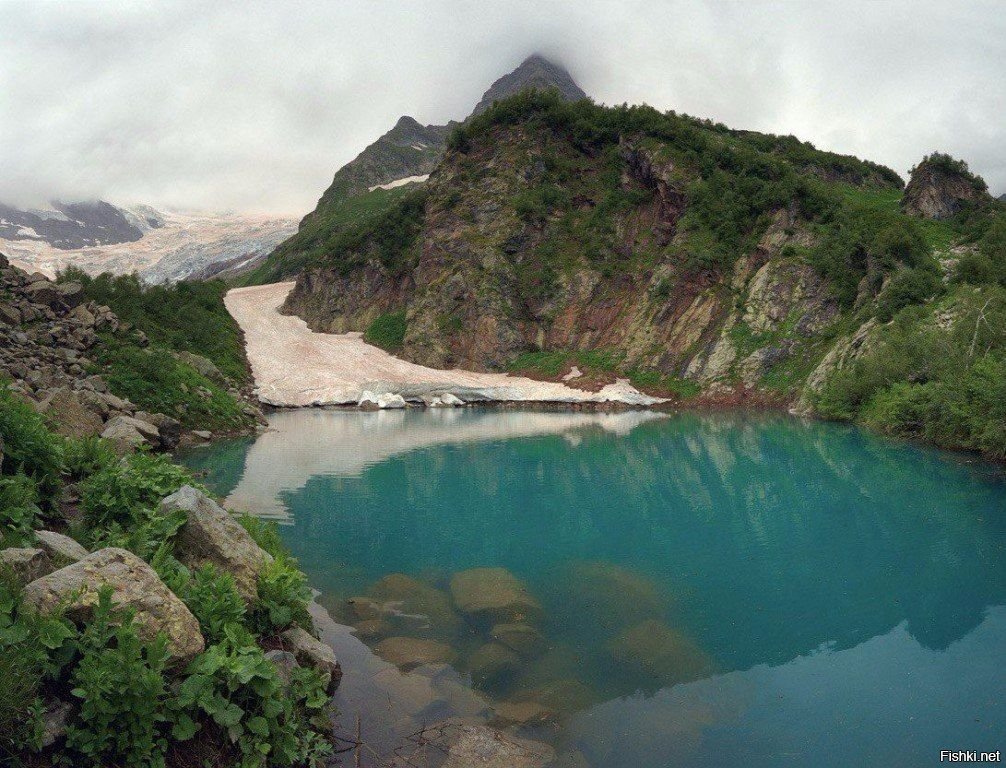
left=0, top=203, right=297, bottom=283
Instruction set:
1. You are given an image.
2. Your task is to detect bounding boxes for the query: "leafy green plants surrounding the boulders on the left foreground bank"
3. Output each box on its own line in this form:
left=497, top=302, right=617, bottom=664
left=0, top=386, right=331, bottom=768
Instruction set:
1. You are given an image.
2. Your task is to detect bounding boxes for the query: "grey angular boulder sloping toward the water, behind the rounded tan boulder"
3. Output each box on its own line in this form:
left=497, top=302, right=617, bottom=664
left=161, top=485, right=273, bottom=603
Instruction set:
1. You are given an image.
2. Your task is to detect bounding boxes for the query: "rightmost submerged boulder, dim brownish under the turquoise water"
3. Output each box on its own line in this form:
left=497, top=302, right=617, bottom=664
left=609, top=619, right=712, bottom=684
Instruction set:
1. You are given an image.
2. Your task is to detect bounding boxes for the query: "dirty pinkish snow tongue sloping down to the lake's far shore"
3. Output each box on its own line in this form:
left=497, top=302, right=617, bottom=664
left=224, top=283, right=661, bottom=408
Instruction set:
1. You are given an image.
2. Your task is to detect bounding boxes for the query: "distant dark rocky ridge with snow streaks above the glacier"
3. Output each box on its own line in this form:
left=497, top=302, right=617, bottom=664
left=0, top=200, right=155, bottom=251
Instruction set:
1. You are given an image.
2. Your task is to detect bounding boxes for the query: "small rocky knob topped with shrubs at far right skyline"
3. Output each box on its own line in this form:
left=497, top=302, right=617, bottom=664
left=901, top=152, right=992, bottom=218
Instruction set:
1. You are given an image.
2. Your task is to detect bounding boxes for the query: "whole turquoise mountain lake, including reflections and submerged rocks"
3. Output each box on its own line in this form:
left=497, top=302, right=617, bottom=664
left=184, top=410, right=1006, bottom=768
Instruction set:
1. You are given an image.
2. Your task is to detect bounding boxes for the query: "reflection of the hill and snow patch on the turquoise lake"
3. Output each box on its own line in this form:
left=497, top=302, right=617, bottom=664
left=187, top=412, right=1006, bottom=695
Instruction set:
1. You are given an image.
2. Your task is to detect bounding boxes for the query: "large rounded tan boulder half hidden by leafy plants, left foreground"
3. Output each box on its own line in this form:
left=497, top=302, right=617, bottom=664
left=23, top=547, right=205, bottom=663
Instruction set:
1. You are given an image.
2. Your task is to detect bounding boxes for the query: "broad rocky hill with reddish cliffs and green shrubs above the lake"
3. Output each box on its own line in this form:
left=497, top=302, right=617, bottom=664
left=277, top=94, right=921, bottom=408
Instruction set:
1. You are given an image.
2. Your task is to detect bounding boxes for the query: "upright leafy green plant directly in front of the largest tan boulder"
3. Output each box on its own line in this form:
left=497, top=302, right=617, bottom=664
left=66, top=587, right=169, bottom=766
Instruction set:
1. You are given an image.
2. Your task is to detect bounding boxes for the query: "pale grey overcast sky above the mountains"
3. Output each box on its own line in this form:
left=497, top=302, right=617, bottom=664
left=0, top=0, right=1006, bottom=215
